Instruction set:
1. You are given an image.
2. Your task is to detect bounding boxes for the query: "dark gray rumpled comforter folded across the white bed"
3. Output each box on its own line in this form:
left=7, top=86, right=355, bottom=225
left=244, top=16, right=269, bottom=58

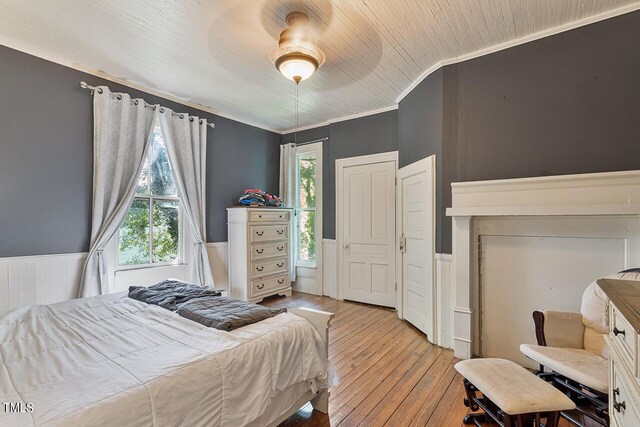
left=129, top=280, right=287, bottom=331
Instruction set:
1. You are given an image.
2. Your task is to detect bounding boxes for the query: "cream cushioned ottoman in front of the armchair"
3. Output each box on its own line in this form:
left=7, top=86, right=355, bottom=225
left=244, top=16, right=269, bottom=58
left=455, top=359, right=576, bottom=427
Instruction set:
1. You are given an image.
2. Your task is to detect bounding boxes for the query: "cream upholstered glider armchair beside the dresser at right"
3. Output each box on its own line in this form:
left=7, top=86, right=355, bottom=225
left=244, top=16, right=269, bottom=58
left=520, top=269, right=640, bottom=426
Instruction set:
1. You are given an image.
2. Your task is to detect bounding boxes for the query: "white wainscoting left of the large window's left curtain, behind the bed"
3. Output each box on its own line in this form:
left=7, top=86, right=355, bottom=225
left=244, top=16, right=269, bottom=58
left=0, top=253, right=87, bottom=311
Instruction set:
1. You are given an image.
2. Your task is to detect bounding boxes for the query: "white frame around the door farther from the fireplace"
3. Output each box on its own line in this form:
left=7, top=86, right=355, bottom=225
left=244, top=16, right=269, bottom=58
left=335, top=151, right=398, bottom=308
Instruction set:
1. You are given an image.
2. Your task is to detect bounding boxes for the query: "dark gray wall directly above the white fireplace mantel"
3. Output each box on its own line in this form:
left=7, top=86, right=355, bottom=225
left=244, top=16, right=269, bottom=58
left=444, top=12, right=640, bottom=181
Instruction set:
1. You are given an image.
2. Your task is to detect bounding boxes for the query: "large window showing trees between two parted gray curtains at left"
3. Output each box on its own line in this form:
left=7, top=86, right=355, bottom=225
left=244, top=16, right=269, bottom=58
left=118, top=125, right=181, bottom=266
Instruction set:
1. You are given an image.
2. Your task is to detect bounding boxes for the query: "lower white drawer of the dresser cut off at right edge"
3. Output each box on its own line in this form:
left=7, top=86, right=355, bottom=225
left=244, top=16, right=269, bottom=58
left=609, top=360, right=640, bottom=427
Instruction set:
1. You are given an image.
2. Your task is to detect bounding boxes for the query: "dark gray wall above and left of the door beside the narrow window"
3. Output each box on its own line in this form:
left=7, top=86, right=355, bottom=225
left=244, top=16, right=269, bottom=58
left=282, top=110, right=398, bottom=239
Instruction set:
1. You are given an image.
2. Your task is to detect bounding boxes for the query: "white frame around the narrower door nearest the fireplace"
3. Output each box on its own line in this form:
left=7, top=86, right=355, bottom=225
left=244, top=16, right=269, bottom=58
left=396, top=154, right=439, bottom=334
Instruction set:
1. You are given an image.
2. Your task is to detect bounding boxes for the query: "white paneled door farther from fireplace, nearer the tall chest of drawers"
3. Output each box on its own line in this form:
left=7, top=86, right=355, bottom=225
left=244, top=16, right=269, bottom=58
left=338, top=156, right=397, bottom=307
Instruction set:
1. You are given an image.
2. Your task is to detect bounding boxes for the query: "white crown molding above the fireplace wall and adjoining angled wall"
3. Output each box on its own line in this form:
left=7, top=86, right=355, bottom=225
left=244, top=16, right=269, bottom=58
left=396, top=1, right=640, bottom=104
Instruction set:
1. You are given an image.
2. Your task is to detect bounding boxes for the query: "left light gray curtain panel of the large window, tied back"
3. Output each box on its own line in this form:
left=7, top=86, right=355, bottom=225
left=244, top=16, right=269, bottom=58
left=78, top=86, right=158, bottom=297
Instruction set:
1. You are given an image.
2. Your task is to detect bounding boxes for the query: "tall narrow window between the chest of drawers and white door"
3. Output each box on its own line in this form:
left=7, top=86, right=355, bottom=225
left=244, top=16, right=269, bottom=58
left=296, top=152, right=317, bottom=265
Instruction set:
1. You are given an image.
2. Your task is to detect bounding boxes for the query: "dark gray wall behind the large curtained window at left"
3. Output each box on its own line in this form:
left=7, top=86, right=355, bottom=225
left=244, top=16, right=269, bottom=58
left=0, top=46, right=281, bottom=257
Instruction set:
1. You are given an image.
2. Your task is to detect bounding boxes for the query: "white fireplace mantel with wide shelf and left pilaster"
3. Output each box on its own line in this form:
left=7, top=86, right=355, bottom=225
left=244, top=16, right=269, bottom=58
left=447, top=171, right=640, bottom=359
